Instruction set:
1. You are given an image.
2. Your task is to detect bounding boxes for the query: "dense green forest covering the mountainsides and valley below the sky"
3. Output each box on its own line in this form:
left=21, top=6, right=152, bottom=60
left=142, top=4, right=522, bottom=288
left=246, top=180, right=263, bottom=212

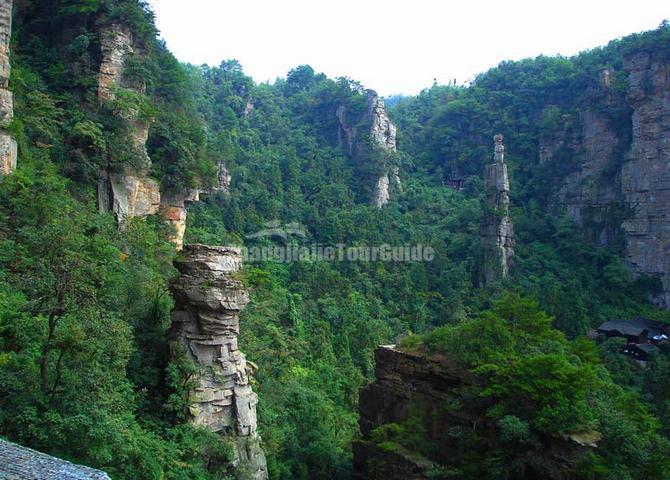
left=0, top=0, right=670, bottom=479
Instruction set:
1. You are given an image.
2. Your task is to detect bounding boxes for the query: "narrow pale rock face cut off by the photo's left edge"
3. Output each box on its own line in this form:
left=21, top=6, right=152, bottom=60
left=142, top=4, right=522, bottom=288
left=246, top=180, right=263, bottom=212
left=0, top=0, right=18, bottom=176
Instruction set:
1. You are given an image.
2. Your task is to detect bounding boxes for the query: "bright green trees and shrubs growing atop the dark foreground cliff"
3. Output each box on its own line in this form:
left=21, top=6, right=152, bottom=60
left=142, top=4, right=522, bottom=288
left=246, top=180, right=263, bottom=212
left=400, top=292, right=670, bottom=479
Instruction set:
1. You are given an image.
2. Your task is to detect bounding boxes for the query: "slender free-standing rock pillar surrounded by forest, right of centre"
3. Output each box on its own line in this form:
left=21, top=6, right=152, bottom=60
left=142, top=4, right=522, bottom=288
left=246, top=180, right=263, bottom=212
left=480, top=134, right=515, bottom=285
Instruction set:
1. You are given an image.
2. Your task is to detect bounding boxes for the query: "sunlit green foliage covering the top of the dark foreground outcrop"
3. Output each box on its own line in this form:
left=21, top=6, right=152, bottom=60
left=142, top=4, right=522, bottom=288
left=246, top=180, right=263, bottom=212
left=403, top=293, right=668, bottom=478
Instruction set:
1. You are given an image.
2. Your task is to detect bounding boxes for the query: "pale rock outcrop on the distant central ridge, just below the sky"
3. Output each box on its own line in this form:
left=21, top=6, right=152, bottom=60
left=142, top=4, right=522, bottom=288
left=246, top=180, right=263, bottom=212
left=337, top=90, right=402, bottom=208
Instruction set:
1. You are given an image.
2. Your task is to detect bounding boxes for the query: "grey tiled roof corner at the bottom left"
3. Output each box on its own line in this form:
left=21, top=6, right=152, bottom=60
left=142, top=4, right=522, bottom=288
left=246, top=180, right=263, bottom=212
left=0, top=440, right=110, bottom=480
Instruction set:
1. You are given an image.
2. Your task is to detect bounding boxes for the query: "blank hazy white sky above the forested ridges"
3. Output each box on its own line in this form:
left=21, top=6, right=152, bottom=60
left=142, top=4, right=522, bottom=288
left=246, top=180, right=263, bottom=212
left=149, top=0, right=670, bottom=95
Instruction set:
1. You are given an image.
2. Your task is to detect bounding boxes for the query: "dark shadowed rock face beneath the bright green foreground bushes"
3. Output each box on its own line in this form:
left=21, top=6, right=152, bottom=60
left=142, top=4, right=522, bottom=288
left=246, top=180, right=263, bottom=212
left=353, top=346, right=588, bottom=480
